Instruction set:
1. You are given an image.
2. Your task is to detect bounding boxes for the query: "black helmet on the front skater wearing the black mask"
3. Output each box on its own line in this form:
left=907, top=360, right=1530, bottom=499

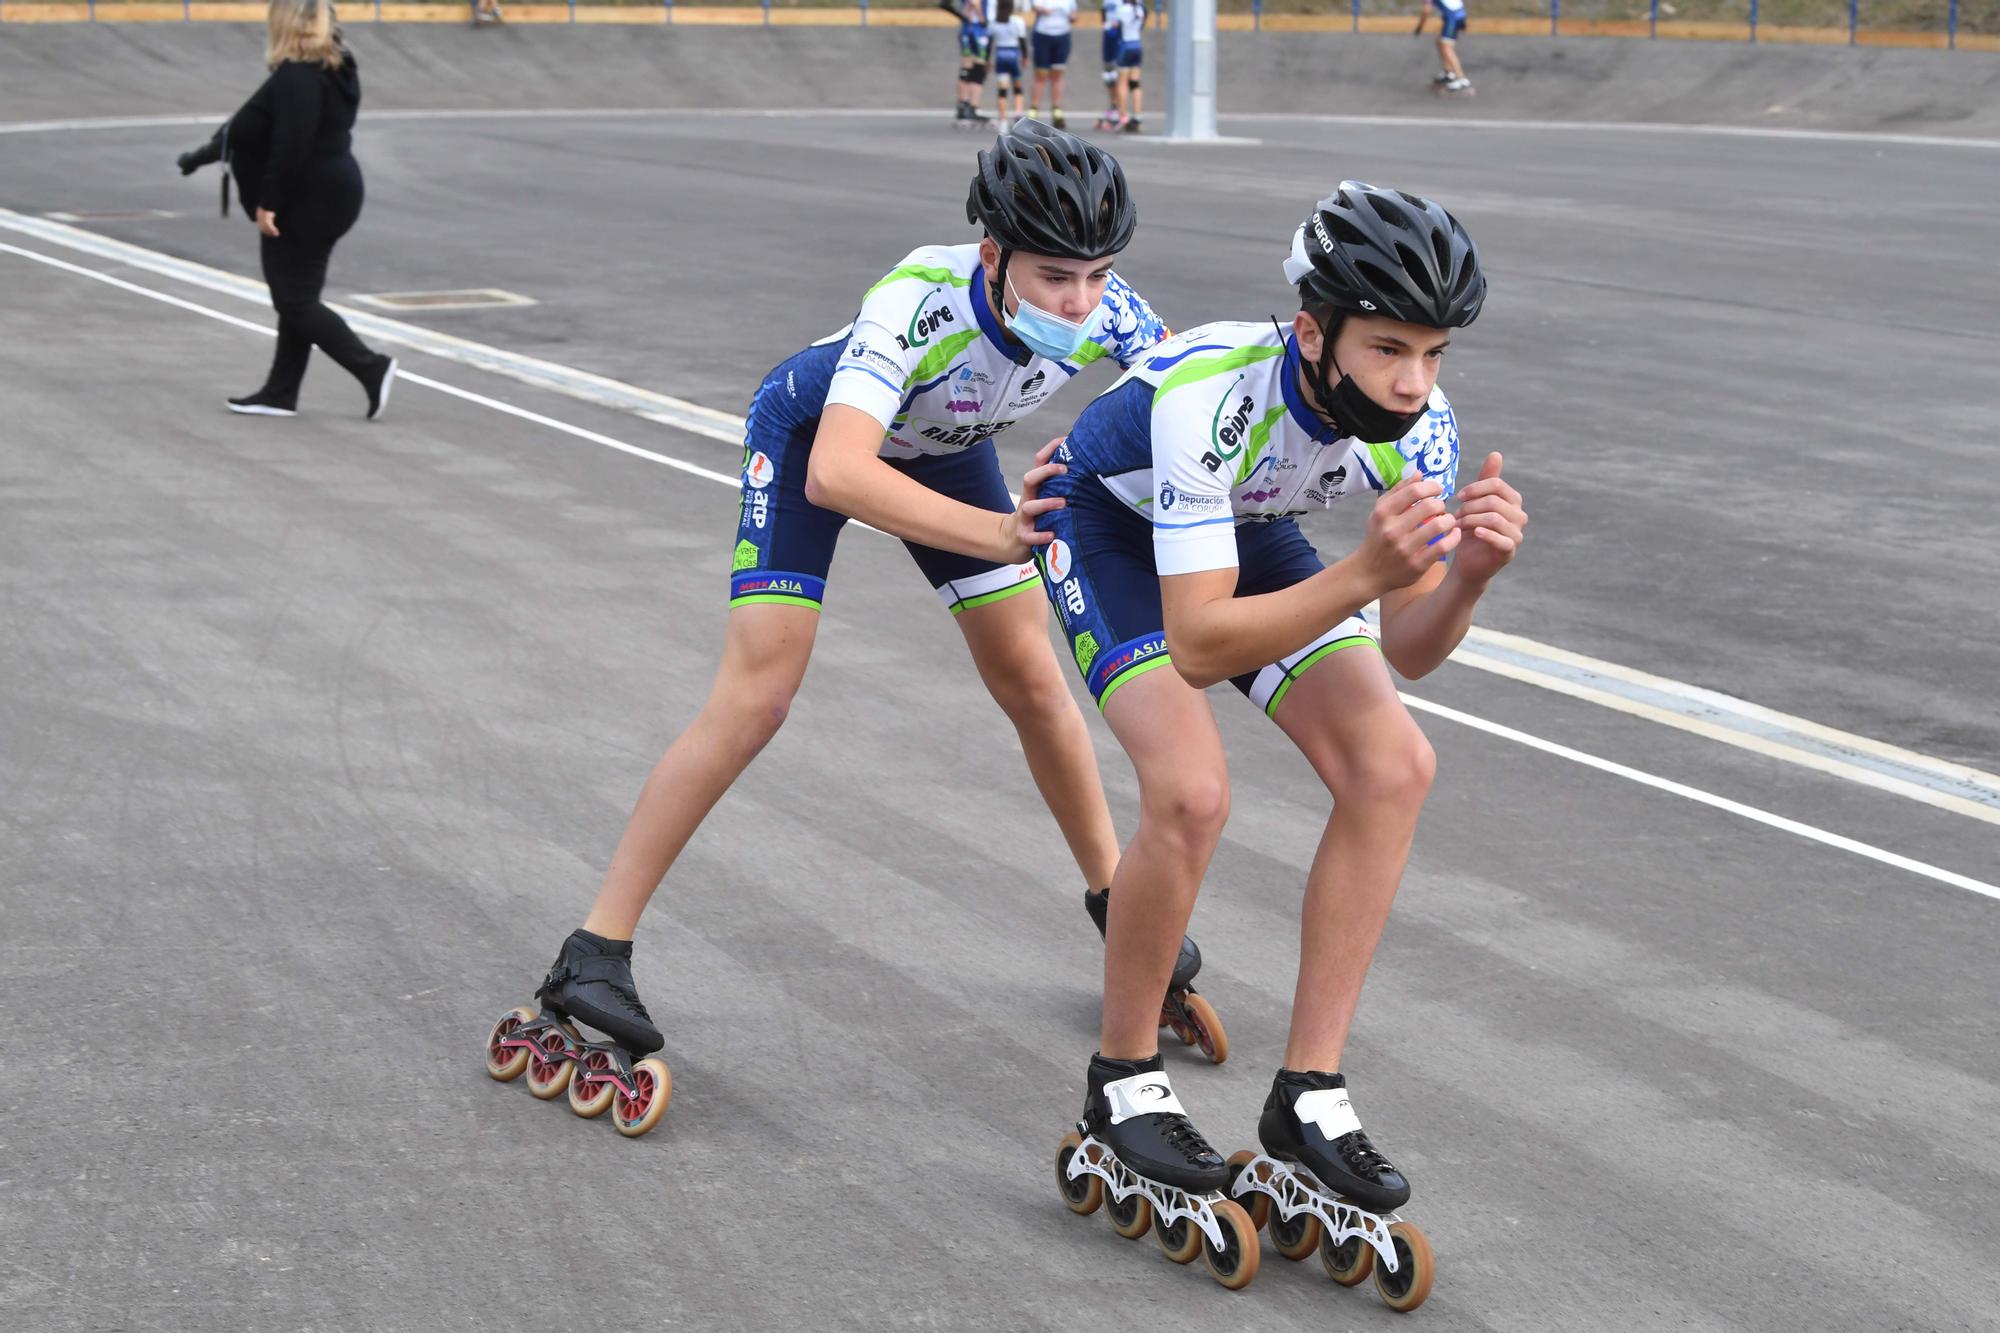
left=1284, top=180, right=1486, bottom=328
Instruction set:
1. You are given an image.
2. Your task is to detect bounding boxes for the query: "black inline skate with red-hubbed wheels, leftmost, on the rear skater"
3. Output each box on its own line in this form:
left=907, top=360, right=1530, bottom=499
left=486, top=931, right=674, bottom=1139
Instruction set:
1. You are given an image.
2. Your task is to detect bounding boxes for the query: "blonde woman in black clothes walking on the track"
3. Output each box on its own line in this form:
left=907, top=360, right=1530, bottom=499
left=180, top=0, right=396, bottom=420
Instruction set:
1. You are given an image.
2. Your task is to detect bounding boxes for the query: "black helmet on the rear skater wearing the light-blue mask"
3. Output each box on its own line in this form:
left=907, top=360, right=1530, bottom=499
left=966, top=120, right=1138, bottom=260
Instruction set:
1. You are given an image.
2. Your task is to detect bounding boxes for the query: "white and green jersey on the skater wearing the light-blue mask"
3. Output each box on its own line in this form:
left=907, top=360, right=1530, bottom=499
left=798, top=244, right=1166, bottom=458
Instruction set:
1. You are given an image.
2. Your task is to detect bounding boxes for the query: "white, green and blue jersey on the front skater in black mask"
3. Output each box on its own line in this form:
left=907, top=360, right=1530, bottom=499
left=1066, top=322, right=1458, bottom=574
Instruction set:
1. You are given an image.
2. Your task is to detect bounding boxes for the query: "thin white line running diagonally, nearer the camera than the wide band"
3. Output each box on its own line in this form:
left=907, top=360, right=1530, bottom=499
left=0, top=242, right=2000, bottom=901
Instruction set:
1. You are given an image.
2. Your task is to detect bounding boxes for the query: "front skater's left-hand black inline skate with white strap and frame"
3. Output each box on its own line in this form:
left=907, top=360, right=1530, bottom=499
left=1056, top=1055, right=1258, bottom=1291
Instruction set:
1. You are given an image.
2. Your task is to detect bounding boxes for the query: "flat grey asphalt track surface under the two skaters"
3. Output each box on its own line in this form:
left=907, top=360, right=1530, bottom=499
left=0, top=98, right=2000, bottom=1329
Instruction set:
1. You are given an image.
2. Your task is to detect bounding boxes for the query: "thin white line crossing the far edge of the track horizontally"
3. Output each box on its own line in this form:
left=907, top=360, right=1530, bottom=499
left=0, top=106, right=2000, bottom=150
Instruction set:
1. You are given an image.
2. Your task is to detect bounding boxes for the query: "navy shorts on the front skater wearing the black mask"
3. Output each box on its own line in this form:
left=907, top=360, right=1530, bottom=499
left=1036, top=460, right=1376, bottom=717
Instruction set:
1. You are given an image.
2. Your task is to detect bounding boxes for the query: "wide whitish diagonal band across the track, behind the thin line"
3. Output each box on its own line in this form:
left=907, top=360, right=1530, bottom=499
left=0, top=208, right=2000, bottom=825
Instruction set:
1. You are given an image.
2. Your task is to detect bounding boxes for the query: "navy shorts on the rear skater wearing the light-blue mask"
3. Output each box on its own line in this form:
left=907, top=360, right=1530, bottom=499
left=730, top=342, right=1036, bottom=616
